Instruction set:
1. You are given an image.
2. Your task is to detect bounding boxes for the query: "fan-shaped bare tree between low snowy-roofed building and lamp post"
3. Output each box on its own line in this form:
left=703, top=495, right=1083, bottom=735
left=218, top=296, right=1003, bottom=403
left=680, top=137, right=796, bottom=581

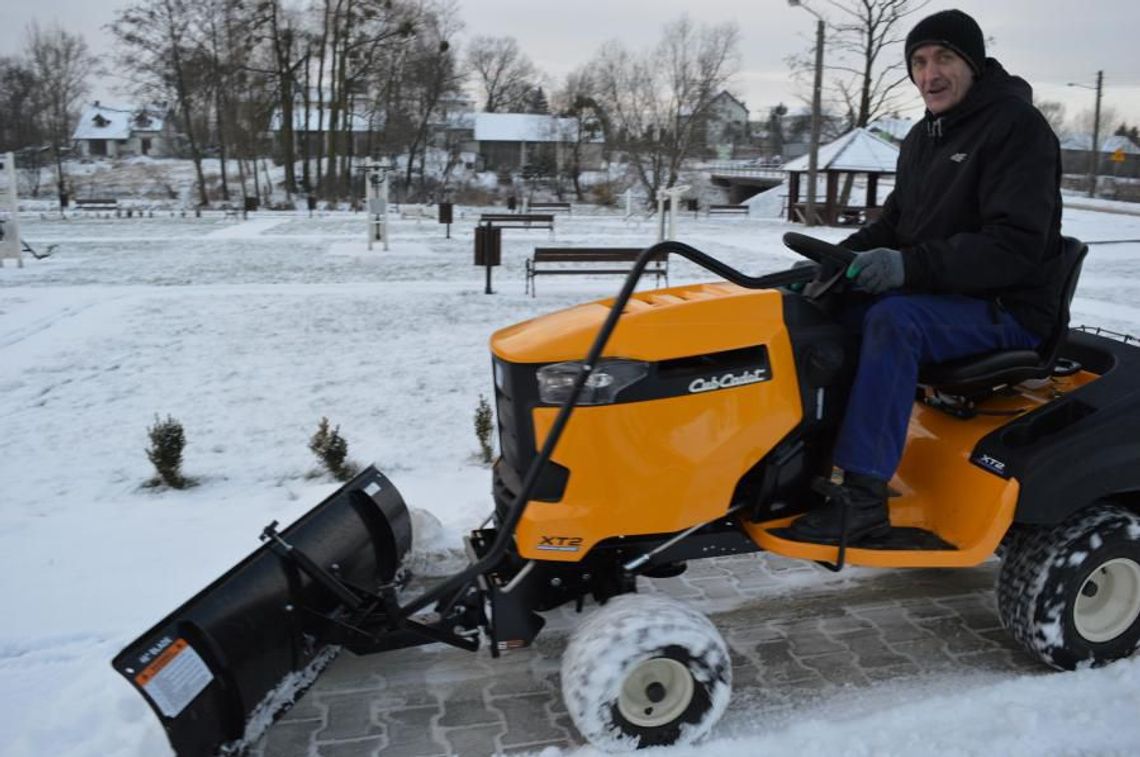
left=591, top=16, right=740, bottom=198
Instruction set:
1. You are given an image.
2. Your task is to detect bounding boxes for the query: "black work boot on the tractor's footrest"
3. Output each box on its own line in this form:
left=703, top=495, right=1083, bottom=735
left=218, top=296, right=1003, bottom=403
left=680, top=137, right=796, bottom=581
left=788, top=473, right=890, bottom=544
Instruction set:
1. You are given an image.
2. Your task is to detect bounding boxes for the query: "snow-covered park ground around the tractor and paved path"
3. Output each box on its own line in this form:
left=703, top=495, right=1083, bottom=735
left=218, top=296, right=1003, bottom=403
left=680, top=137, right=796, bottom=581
left=0, top=201, right=1140, bottom=757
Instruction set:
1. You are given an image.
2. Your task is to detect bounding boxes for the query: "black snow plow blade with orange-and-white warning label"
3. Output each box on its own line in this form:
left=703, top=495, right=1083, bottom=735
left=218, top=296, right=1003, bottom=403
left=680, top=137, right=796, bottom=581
left=112, top=466, right=412, bottom=757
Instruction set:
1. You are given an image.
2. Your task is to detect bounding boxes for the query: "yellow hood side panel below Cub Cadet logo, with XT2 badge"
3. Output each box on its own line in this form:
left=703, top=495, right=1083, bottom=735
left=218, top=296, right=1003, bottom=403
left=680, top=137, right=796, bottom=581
left=515, top=310, right=800, bottom=561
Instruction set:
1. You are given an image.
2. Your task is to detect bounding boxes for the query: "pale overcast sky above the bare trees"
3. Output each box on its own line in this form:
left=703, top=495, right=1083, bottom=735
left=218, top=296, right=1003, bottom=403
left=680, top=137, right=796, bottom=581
left=0, top=0, right=1140, bottom=129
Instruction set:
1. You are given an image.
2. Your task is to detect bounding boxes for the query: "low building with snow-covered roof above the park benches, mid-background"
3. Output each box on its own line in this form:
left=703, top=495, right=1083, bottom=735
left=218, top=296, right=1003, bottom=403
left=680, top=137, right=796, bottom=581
left=474, top=113, right=605, bottom=171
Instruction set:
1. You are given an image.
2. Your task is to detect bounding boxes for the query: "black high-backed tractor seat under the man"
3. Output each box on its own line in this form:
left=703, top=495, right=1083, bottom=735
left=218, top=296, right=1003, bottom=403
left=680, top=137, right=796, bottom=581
left=919, top=237, right=1089, bottom=398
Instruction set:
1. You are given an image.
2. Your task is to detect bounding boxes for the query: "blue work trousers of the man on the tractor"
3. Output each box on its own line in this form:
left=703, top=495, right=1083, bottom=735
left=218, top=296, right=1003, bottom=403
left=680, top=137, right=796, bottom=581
left=834, top=293, right=1041, bottom=480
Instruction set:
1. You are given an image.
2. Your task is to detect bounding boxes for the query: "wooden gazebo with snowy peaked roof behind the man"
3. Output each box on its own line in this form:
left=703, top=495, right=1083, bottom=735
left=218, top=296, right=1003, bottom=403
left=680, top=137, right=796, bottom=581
left=784, top=129, right=898, bottom=226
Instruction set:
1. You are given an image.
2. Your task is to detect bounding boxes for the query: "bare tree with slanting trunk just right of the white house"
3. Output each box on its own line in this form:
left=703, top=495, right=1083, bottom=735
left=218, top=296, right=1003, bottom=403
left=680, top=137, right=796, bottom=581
left=111, top=0, right=210, bottom=206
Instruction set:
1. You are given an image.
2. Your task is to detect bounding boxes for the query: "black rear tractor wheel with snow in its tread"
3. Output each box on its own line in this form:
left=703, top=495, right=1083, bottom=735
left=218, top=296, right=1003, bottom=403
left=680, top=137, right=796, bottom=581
left=998, top=505, right=1140, bottom=670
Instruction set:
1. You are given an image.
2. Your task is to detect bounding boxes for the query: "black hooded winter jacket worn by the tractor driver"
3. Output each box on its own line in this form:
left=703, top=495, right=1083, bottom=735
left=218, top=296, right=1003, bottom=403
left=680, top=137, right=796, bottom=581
left=841, top=58, right=1062, bottom=337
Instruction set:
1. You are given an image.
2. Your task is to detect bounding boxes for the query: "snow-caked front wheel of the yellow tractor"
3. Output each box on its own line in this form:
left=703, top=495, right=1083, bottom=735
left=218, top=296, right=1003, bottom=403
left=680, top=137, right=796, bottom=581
left=562, top=594, right=732, bottom=751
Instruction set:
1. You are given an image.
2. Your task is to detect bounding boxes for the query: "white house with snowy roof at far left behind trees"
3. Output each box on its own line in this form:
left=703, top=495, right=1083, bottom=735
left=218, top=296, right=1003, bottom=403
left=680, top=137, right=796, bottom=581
left=72, top=100, right=179, bottom=157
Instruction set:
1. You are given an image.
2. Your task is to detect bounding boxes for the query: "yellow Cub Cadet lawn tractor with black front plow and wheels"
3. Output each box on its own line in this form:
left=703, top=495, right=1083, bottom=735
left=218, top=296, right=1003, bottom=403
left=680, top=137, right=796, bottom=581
left=113, top=234, right=1140, bottom=755
